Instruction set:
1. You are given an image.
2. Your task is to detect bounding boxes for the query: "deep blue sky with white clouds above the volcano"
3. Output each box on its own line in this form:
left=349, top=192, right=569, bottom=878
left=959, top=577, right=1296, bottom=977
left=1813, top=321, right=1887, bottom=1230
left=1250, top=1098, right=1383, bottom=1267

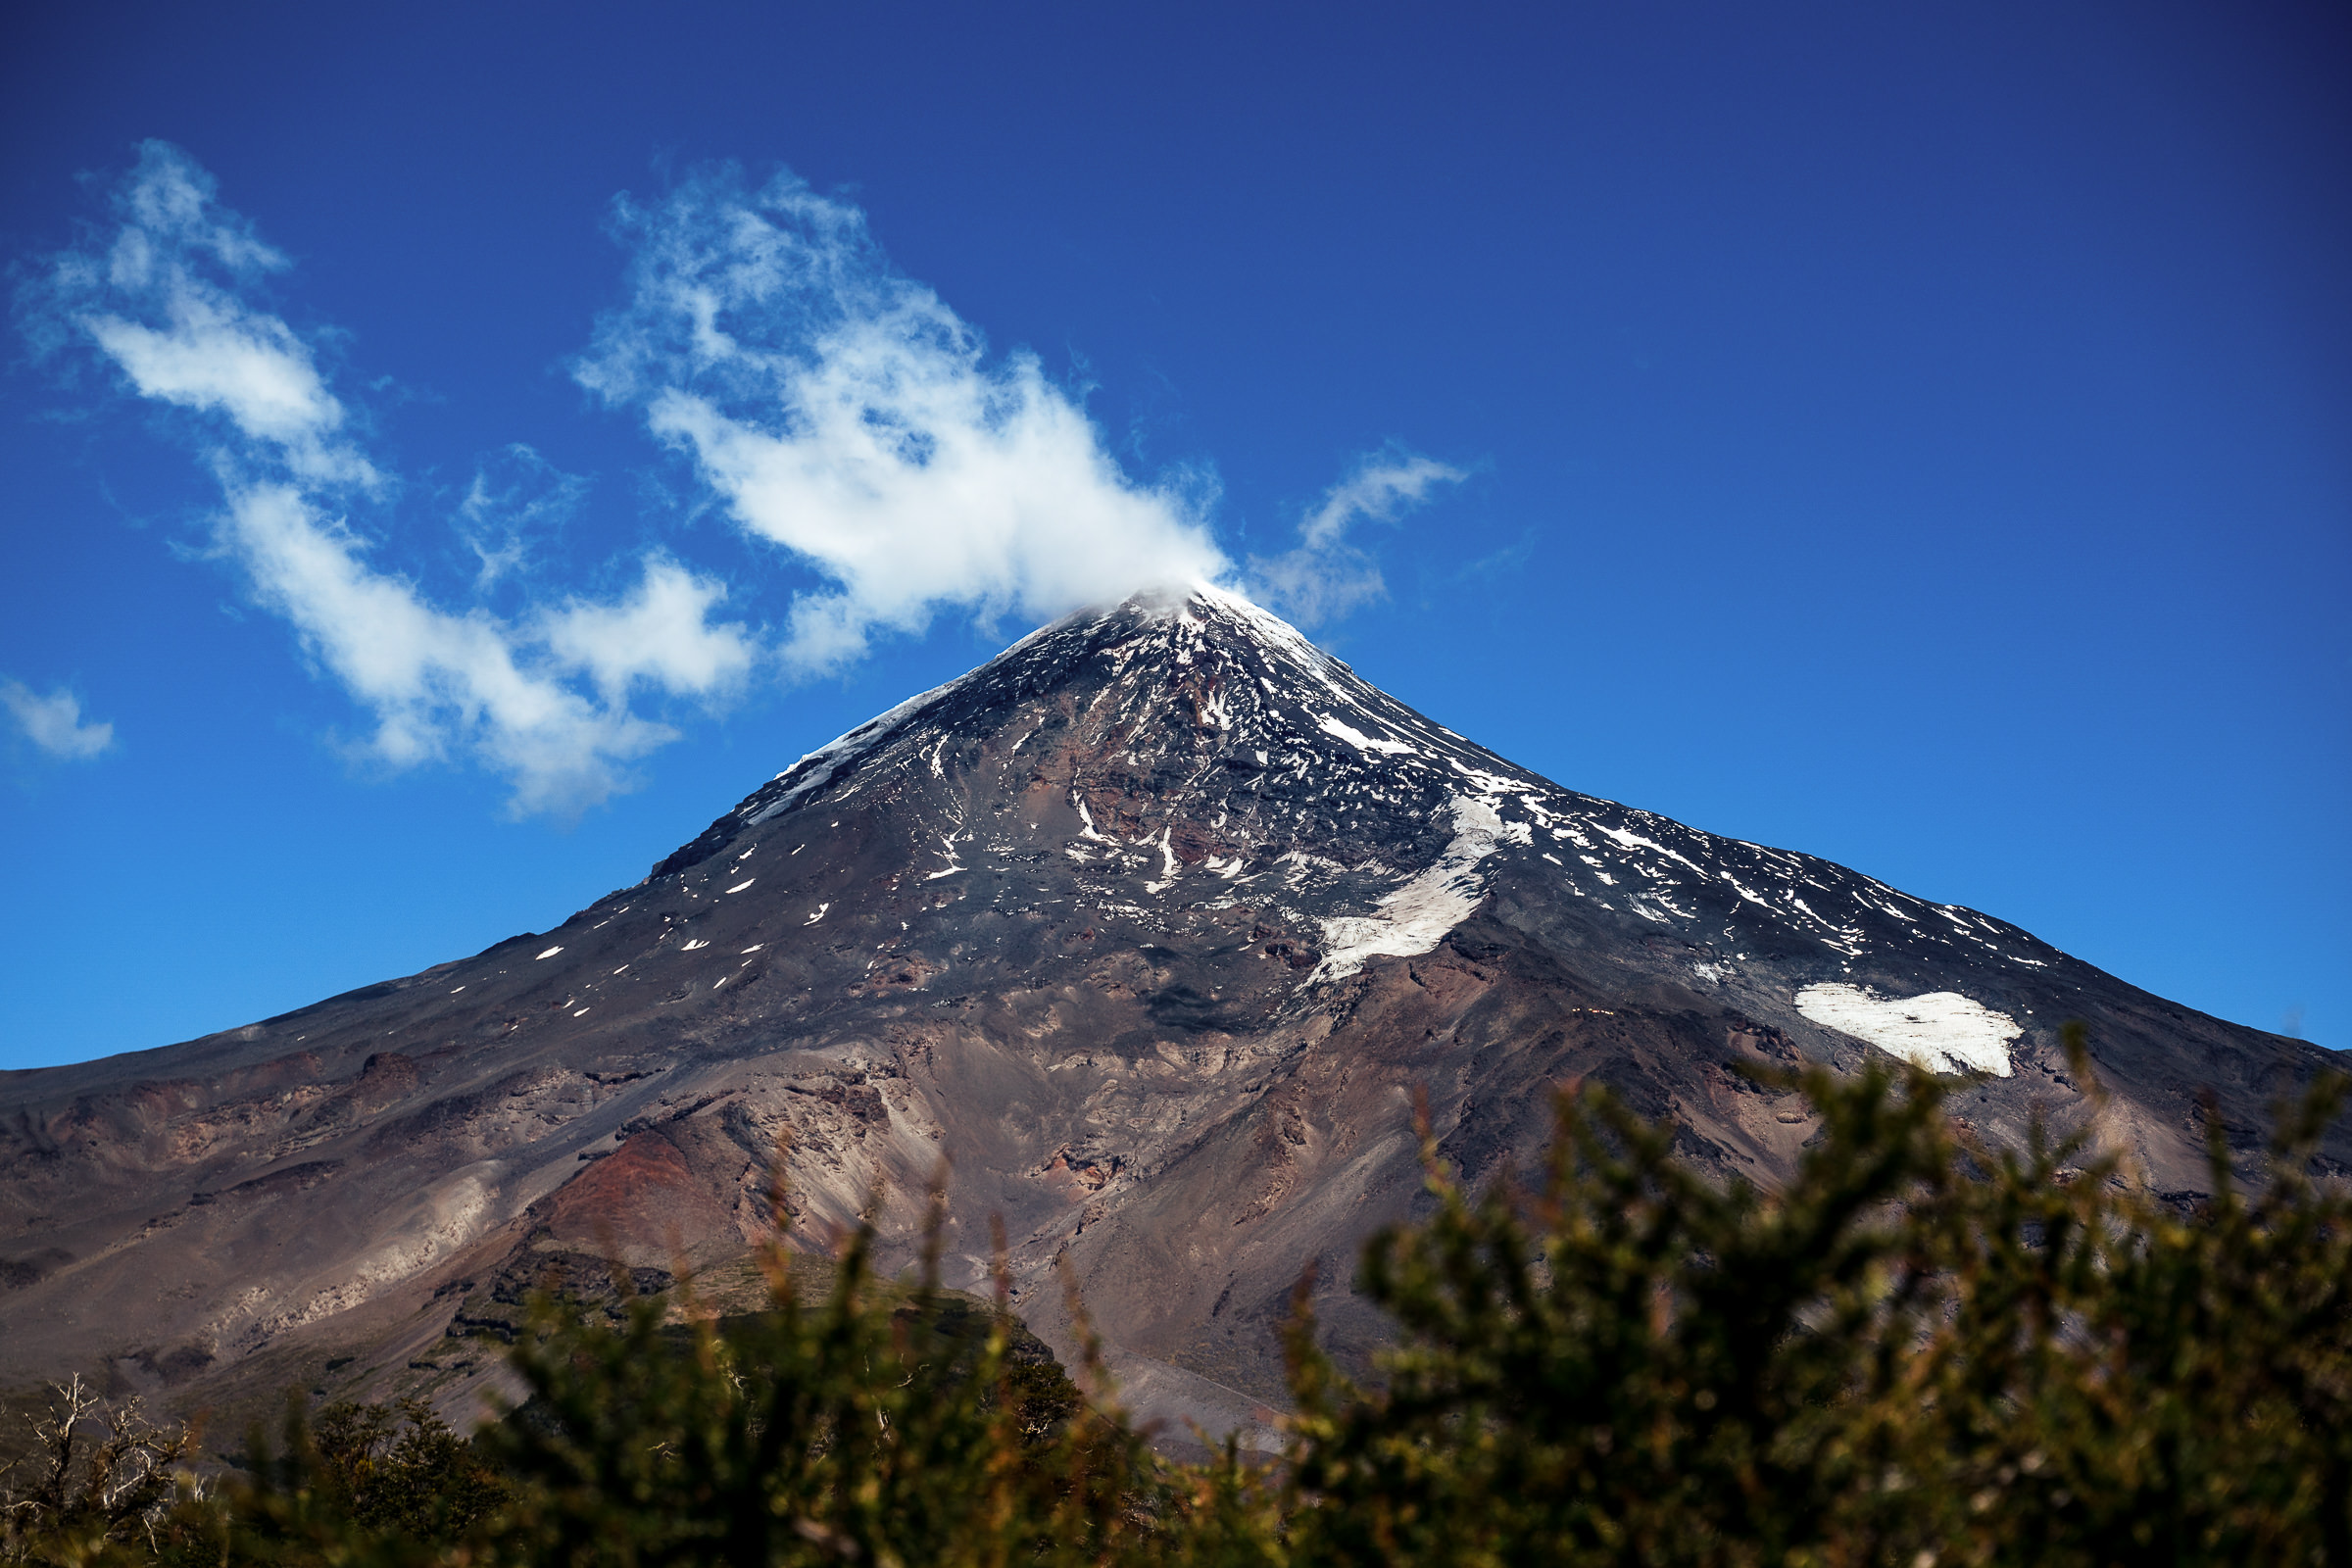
left=0, top=2, right=2352, bottom=1065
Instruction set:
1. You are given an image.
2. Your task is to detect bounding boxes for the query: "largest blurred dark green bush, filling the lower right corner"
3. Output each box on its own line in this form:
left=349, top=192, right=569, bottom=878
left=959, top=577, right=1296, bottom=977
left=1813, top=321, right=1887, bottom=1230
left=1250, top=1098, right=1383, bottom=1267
left=1289, top=1032, right=2352, bottom=1566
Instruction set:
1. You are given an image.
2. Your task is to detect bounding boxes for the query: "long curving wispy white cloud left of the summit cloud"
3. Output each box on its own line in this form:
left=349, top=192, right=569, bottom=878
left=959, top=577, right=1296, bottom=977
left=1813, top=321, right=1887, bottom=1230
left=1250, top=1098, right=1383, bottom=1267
left=25, top=141, right=758, bottom=813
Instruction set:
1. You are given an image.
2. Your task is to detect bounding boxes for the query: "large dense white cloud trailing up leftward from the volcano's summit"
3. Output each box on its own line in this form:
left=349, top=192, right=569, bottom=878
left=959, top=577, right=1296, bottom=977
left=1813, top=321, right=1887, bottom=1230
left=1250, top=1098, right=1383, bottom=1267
left=576, top=172, right=1230, bottom=672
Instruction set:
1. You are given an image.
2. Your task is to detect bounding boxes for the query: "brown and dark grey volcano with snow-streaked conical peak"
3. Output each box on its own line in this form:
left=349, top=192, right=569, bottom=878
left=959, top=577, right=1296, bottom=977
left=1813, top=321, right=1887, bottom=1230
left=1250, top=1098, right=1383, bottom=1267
left=0, top=588, right=2352, bottom=1429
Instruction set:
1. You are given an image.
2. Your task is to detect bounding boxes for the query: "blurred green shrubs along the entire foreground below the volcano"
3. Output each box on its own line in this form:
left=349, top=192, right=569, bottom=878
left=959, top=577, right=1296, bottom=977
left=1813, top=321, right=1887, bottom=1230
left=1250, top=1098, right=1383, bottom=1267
left=5, top=1037, right=2352, bottom=1568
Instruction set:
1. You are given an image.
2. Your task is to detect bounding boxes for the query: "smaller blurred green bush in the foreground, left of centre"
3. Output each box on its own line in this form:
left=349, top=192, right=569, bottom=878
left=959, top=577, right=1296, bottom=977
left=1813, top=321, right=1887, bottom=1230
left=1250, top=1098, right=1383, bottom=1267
left=472, top=1234, right=1171, bottom=1566
